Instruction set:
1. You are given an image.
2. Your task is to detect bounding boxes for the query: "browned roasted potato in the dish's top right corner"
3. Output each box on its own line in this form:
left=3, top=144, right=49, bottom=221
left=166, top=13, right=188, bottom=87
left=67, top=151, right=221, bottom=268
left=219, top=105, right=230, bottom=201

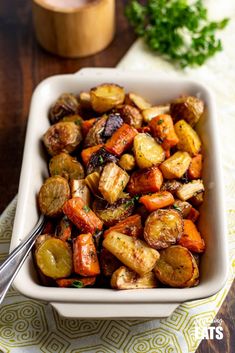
left=170, top=96, right=204, bottom=127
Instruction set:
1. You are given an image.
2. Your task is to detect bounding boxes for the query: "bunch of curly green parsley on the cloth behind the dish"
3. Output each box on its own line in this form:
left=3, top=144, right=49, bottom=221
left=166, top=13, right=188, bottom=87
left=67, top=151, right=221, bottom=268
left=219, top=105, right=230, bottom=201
left=125, top=0, right=229, bottom=68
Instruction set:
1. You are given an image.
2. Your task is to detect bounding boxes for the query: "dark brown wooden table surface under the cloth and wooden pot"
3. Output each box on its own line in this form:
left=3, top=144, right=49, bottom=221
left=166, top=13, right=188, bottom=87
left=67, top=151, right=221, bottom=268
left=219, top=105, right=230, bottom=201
left=0, top=0, right=235, bottom=353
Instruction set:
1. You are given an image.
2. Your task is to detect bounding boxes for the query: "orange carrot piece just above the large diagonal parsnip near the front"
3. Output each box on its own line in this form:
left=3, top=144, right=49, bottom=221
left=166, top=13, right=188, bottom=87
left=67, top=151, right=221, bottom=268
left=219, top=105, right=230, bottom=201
left=104, top=214, right=143, bottom=238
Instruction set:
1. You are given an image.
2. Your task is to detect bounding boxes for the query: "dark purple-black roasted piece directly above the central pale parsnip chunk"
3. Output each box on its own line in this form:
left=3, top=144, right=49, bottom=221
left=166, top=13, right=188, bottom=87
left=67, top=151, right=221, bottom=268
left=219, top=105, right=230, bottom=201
left=87, top=147, right=118, bottom=174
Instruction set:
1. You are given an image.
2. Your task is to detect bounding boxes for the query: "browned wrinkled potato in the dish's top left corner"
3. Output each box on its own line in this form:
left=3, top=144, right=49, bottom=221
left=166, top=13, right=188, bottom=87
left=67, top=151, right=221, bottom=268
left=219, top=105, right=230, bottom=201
left=49, top=93, right=79, bottom=124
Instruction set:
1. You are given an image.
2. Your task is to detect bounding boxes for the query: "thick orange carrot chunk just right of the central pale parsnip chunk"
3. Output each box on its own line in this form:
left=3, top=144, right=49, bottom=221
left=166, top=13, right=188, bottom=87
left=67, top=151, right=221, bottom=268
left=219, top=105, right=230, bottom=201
left=127, top=167, right=163, bottom=195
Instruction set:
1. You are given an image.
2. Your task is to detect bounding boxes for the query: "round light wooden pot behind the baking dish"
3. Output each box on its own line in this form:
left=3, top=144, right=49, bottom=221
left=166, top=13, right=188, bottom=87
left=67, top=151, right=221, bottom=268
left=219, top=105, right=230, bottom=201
left=33, top=0, right=115, bottom=58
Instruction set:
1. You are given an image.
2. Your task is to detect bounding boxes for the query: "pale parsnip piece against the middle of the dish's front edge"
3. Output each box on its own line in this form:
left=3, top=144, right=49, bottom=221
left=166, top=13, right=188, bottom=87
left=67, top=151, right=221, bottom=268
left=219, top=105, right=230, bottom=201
left=111, top=266, right=157, bottom=289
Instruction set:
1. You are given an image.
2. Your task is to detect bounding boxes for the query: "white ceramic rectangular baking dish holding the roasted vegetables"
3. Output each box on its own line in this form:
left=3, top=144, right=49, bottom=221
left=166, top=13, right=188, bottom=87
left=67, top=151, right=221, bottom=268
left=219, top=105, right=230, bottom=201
left=11, top=69, right=228, bottom=318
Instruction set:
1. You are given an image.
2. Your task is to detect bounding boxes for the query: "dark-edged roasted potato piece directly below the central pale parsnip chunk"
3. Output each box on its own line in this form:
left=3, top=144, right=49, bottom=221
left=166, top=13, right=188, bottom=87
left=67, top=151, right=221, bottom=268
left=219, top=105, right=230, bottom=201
left=92, top=197, right=135, bottom=227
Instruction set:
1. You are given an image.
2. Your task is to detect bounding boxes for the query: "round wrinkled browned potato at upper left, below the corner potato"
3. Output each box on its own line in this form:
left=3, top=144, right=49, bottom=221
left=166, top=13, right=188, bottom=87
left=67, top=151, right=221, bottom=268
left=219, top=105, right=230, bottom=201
left=43, top=122, right=82, bottom=156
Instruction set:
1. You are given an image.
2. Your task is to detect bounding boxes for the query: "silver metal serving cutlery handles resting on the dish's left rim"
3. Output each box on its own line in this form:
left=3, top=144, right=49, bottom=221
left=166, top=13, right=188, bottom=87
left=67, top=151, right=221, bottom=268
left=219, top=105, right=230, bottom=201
left=0, top=215, right=46, bottom=304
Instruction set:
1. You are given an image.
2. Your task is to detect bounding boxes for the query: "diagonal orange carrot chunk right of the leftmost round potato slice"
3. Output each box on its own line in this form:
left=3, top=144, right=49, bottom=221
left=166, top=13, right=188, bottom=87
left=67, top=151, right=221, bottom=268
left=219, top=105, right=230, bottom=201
left=63, top=197, right=103, bottom=234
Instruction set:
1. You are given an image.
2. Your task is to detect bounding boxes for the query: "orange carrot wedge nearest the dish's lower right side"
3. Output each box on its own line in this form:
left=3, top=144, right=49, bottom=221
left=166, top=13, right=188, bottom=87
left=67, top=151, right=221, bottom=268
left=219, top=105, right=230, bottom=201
left=178, top=219, right=205, bottom=253
